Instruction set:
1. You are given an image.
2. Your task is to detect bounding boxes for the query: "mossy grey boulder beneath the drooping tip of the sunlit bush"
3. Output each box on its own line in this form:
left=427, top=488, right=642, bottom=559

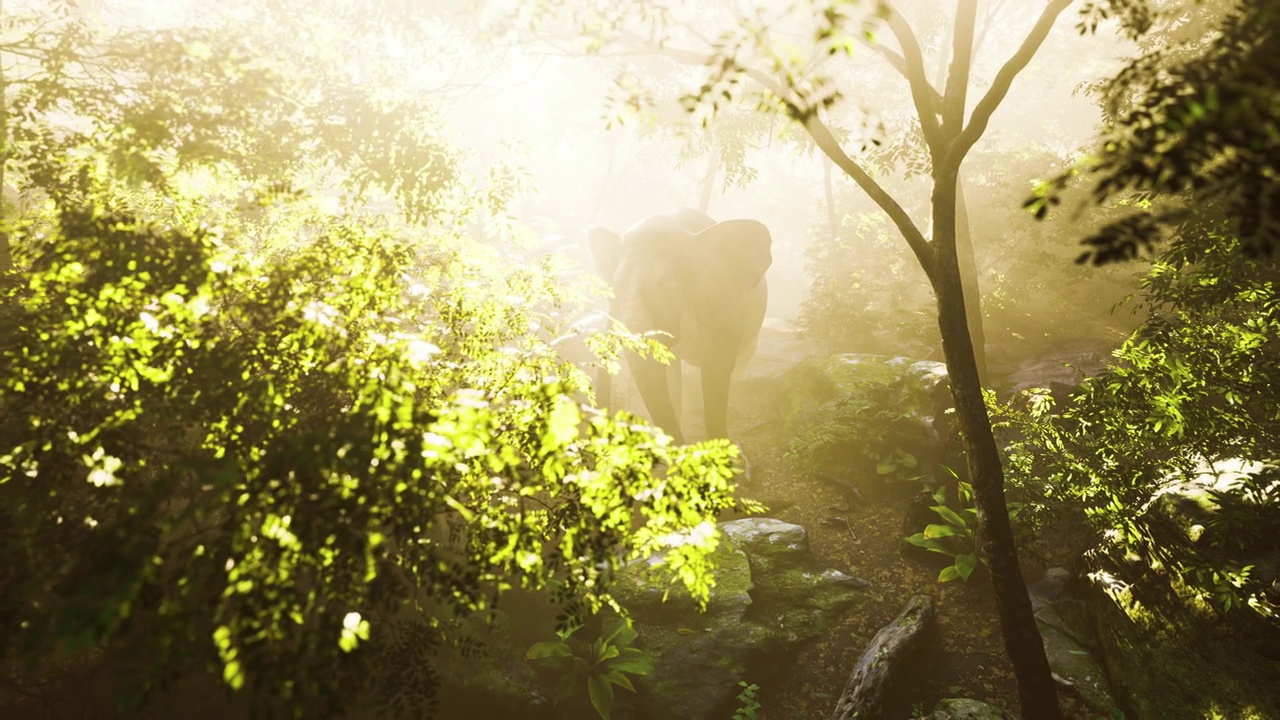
left=614, top=518, right=867, bottom=719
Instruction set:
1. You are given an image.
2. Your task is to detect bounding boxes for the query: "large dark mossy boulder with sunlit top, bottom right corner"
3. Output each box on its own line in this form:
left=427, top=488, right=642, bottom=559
left=1085, top=460, right=1280, bottom=720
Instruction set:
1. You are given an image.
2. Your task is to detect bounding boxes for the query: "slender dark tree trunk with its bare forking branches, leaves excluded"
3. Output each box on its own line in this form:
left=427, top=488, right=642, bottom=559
left=668, top=0, right=1071, bottom=707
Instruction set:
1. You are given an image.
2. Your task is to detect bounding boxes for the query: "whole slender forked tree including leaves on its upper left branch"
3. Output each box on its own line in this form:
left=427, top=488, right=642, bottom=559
left=512, top=0, right=1090, bottom=719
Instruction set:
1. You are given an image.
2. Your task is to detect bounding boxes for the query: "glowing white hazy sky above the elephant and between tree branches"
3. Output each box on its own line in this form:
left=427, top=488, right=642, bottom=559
left=47, top=0, right=1129, bottom=318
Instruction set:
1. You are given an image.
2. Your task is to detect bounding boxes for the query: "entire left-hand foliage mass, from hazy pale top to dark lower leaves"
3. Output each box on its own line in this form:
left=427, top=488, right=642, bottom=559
left=0, top=2, right=736, bottom=716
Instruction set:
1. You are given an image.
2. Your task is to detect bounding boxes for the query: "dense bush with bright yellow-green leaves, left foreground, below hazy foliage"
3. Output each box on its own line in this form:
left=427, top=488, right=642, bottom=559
left=0, top=197, right=747, bottom=702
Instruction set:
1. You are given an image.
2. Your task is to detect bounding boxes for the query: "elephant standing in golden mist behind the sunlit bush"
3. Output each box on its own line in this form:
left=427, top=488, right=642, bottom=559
left=588, top=208, right=773, bottom=443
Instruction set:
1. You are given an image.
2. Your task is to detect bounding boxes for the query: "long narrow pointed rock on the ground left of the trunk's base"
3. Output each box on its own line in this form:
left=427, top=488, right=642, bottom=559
left=831, top=594, right=934, bottom=720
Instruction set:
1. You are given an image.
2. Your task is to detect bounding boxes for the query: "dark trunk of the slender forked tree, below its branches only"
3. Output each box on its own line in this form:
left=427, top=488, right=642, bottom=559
left=932, top=168, right=1061, bottom=720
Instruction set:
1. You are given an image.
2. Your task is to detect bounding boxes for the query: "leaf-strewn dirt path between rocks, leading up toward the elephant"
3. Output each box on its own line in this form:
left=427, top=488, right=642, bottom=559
left=731, top=358, right=1111, bottom=720
